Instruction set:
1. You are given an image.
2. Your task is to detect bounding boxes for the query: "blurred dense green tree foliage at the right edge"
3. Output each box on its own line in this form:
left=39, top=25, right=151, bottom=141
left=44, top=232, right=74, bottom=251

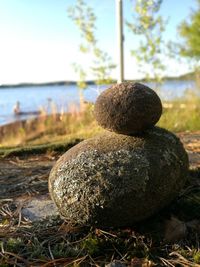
left=178, top=0, right=200, bottom=84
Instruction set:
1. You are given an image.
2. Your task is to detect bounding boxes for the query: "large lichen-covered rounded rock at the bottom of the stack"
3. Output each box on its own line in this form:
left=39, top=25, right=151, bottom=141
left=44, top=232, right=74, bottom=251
left=49, top=127, right=188, bottom=227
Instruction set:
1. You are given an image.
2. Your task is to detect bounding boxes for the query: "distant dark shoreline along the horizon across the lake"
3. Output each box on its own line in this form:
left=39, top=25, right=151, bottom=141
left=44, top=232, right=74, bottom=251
left=0, top=72, right=195, bottom=89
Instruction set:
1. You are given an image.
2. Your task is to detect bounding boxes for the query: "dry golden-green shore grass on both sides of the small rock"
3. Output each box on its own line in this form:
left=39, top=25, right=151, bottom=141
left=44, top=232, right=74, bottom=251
left=0, top=92, right=200, bottom=147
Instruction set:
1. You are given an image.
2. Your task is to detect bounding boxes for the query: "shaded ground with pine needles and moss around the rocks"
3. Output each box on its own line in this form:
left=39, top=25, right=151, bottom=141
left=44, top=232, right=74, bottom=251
left=0, top=132, right=200, bottom=266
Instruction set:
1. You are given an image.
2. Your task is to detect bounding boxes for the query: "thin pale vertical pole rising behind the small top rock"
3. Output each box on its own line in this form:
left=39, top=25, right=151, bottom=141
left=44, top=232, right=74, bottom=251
left=116, top=0, right=124, bottom=83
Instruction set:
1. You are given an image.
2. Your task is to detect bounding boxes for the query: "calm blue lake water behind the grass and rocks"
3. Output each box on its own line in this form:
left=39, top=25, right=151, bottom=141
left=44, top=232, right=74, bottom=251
left=0, top=81, right=194, bottom=125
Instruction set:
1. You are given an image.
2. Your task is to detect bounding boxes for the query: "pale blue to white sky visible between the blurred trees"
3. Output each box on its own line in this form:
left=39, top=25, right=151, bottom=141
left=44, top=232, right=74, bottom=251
left=0, top=0, right=196, bottom=84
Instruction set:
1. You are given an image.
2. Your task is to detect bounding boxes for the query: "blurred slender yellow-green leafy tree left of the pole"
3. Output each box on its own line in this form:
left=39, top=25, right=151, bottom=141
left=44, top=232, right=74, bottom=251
left=68, top=0, right=115, bottom=88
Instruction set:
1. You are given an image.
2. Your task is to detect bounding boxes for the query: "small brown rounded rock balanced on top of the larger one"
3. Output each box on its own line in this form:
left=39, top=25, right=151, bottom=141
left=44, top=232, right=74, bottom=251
left=94, top=83, right=162, bottom=134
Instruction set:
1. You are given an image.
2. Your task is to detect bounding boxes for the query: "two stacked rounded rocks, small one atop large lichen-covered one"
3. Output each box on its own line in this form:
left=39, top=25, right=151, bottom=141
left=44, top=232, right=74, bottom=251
left=49, top=83, right=188, bottom=227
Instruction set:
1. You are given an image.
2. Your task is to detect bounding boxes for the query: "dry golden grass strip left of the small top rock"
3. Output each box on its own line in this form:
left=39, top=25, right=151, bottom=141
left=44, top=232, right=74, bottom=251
left=0, top=104, right=101, bottom=147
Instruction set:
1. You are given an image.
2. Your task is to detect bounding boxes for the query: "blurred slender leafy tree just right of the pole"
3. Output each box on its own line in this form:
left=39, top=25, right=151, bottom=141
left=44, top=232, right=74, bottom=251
left=126, top=0, right=166, bottom=82
